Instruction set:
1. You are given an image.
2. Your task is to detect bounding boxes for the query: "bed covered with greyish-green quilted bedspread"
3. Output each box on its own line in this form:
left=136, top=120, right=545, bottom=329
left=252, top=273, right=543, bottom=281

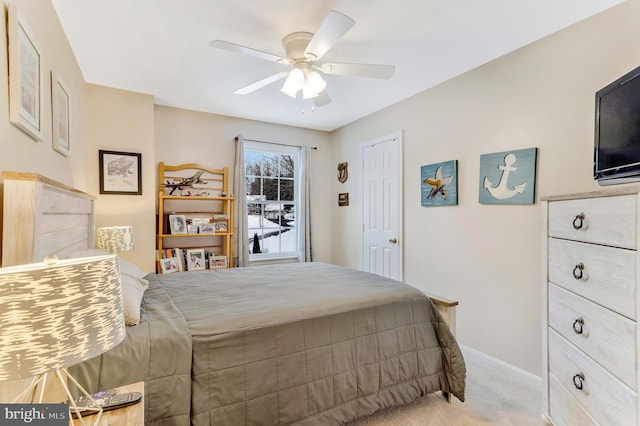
left=3, top=171, right=466, bottom=425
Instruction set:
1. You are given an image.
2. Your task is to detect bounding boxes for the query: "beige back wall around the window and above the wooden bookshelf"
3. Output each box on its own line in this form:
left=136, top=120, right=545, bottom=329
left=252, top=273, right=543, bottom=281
left=155, top=106, right=337, bottom=262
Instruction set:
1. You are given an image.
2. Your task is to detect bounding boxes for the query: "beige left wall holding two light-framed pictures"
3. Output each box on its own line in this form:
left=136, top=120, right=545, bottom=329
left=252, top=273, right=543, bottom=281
left=0, top=0, right=91, bottom=188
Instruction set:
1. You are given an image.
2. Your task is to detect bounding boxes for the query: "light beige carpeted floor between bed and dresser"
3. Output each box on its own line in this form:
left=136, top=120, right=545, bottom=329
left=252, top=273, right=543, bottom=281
left=350, top=350, right=546, bottom=426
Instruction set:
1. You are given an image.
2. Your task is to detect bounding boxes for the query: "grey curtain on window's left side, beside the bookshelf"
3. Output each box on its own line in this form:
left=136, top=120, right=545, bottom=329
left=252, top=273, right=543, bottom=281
left=233, top=136, right=249, bottom=267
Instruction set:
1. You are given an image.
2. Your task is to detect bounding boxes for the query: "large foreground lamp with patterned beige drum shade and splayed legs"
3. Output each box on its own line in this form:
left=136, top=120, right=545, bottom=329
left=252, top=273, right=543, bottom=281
left=0, top=255, right=126, bottom=424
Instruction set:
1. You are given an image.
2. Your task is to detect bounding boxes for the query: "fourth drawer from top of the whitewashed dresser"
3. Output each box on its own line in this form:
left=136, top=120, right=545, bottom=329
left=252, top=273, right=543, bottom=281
left=549, top=329, right=638, bottom=426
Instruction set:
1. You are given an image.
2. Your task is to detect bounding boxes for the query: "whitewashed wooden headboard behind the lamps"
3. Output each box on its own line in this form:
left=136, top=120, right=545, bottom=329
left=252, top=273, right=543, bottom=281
left=2, top=171, right=96, bottom=266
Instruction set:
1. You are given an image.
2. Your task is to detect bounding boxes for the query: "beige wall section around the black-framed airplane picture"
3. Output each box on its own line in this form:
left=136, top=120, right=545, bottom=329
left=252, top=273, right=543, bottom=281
left=87, top=84, right=156, bottom=272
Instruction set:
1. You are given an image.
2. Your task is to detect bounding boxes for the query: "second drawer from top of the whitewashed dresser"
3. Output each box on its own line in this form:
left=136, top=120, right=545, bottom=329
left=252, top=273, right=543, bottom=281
left=548, top=238, right=637, bottom=318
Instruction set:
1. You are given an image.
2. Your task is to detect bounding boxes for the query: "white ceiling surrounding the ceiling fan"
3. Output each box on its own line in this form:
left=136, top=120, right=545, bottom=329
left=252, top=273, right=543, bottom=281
left=52, top=0, right=622, bottom=131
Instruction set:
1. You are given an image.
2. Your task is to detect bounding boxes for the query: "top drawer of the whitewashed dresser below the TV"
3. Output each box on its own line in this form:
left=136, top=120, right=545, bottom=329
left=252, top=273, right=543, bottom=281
left=549, top=195, right=636, bottom=249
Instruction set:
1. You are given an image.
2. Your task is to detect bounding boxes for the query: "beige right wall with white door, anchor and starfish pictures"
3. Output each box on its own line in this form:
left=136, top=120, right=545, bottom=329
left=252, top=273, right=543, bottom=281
left=331, top=0, right=640, bottom=375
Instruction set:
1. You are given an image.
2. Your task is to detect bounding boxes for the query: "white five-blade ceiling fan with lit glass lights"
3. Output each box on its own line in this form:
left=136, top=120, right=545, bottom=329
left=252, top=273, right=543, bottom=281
left=209, top=10, right=395, bottom=107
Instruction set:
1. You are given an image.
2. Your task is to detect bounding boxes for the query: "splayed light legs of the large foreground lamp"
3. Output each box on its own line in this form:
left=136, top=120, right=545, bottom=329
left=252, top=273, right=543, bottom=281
left=11, top=368, right=102, bottom=426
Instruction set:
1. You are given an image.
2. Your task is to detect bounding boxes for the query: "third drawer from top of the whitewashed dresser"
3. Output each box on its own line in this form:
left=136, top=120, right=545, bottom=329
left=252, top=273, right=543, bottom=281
left=549, top=284, right=636, bottom=389
